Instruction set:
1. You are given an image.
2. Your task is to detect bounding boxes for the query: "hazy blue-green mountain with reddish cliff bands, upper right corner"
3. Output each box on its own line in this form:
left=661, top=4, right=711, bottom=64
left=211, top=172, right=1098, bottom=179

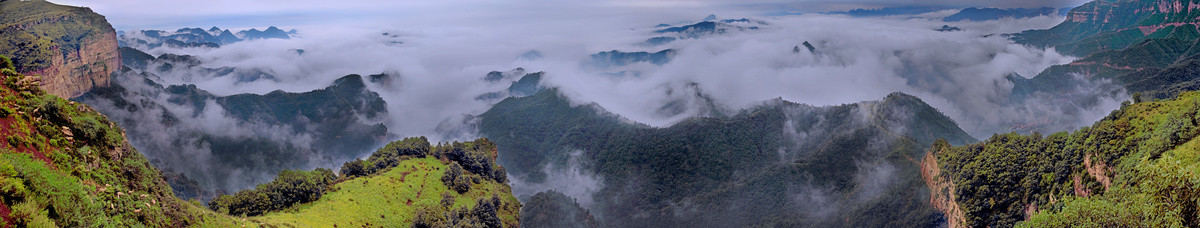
left=1013, top=0, right=1200, bottom=98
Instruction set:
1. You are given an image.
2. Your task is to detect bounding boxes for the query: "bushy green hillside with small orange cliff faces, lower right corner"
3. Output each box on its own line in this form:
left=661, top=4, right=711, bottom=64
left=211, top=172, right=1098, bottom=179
left=932, top=91, right=1200, bottom=227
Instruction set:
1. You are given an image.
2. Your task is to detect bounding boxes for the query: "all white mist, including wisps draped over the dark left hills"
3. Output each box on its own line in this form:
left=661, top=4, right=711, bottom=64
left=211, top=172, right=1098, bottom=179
left=82, top=2, right=1126, bottom=217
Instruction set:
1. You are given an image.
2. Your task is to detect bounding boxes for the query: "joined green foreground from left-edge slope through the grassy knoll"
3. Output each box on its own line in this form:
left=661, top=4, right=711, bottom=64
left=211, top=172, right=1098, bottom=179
left=0, top=54, right=521, bottom=227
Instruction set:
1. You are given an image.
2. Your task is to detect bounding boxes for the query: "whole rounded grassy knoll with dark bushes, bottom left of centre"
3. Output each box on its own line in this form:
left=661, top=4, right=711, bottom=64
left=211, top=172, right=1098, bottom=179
left=241, top=137, right=521, bottom=227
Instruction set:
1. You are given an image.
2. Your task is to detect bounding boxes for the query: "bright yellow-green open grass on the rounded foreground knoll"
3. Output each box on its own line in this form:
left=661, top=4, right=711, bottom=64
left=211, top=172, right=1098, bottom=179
left=251, top=157, right=520, bottom=227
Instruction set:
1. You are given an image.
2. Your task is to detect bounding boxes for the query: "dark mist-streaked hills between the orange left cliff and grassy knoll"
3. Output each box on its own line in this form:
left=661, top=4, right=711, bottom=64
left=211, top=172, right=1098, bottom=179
left=74, top=66, right=388, bottom=198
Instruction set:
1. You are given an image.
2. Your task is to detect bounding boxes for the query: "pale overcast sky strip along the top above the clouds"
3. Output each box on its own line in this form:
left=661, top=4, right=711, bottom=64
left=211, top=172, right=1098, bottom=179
left=50, top=0, right=1086, bottom=30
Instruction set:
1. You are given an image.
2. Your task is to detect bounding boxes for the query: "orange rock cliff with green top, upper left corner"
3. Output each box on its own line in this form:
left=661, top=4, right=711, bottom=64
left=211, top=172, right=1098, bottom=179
left=0, top=0, right=121, bottom=97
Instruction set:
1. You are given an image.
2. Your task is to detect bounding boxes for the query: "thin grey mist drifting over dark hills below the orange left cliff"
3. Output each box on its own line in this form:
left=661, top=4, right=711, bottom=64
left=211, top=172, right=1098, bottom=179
left=84, top=72, right=332, bottom=191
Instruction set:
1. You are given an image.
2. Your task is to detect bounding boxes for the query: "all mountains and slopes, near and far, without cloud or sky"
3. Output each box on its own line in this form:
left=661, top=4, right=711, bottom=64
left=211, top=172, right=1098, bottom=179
left=0, top=0, right=1200, bottom=227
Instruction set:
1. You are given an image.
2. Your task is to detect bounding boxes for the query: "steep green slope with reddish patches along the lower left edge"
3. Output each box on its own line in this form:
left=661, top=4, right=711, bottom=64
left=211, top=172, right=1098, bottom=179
left=0, top=58, right=248, bottom=227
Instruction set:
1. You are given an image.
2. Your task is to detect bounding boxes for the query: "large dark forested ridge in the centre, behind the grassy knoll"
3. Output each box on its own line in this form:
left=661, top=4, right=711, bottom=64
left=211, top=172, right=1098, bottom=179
left=479, top=89, right=974, bottom=227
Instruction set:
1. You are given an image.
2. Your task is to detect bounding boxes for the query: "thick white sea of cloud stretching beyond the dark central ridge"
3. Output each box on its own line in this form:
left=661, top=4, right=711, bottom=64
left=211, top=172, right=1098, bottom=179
left=87, top=1, right=1123, bottom=206
